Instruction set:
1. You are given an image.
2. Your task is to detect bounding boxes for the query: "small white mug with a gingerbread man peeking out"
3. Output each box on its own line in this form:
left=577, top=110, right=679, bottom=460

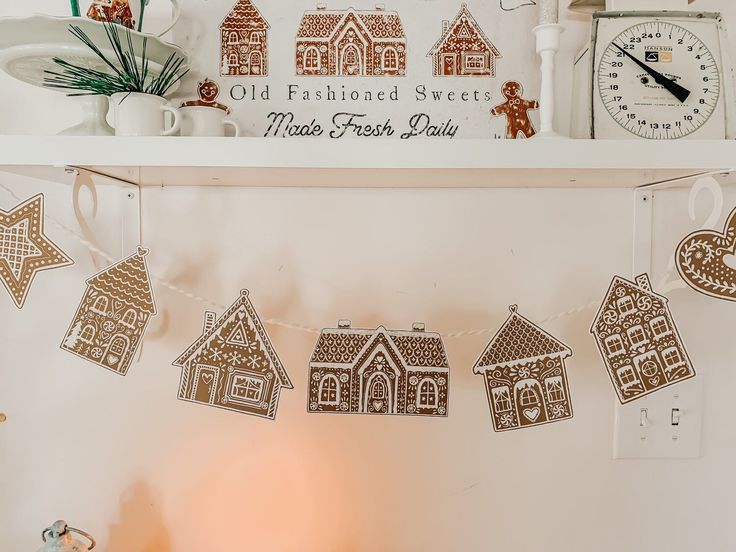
left=180, top=79, right=240, bottom=136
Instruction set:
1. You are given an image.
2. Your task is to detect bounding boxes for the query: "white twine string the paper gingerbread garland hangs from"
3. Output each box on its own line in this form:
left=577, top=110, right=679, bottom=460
left=0, top=184, right=674, bottom=339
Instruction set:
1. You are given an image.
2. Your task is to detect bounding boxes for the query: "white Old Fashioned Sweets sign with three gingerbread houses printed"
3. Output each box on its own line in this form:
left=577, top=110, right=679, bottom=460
left=173, top=0, right=540, bottom=140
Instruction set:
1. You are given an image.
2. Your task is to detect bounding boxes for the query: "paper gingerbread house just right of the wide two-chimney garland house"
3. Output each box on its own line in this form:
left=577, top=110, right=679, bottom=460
left=473, top=305, right=572, bottom=431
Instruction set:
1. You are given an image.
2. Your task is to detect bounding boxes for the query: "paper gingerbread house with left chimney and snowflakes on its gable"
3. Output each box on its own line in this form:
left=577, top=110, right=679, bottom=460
left=174, top=290, right=293, bottom=420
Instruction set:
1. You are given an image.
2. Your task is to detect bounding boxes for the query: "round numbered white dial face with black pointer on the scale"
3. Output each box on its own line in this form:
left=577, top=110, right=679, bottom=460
left=598, top=21, right=721, bottom=140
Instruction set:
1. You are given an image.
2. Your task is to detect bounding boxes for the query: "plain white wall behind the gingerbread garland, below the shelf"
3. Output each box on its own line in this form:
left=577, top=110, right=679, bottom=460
left=0, top=0, right=736, bottom=552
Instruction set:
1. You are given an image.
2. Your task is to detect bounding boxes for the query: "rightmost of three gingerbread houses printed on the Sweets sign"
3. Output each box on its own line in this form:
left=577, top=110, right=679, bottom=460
left=427, top=4, right=501, bottom=77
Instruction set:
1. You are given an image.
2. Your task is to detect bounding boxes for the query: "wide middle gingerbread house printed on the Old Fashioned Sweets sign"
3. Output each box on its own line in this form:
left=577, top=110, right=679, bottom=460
left=296, top=4, right=406, bottom=77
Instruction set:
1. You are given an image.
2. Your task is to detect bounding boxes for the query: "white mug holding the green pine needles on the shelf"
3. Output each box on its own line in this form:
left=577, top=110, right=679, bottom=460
left=110, top=92, right=181, bottom=136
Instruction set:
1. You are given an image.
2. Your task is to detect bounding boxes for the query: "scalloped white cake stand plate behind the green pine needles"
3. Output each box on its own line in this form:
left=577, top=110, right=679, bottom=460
left=0, top=15, right=187, bottom=92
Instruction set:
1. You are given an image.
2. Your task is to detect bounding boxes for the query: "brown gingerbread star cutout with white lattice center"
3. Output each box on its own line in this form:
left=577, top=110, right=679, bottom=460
left=0, top=194, right=74, bottom=309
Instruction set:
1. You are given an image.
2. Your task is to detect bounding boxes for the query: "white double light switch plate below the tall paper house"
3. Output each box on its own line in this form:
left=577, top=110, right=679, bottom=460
left=613, top=374, right=703, bottom=458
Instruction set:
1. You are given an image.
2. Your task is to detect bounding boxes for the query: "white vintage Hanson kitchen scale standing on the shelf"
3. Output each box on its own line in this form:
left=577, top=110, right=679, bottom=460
left=570, top=0, right=736, bottom=140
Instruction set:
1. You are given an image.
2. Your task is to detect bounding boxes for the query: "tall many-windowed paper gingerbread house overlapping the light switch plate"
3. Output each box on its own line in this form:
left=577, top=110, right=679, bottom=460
left=590, top=274, right=695, bottom=404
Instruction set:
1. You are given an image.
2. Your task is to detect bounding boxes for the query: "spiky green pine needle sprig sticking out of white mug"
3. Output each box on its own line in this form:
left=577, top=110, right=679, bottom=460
left=43, top=23, right=189, bottom=96
